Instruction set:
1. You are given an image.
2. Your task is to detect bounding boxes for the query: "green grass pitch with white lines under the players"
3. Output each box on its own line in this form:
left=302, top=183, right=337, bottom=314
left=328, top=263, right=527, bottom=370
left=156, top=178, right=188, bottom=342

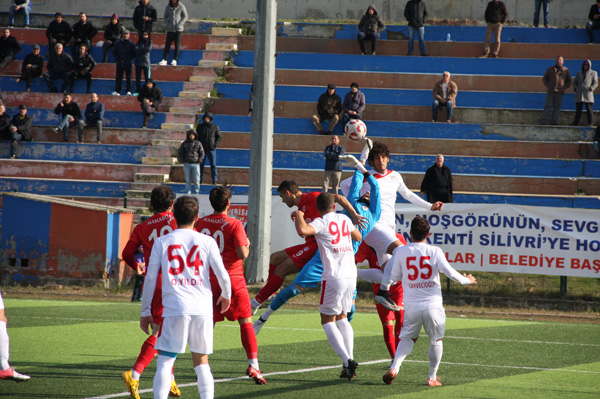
left=0, top=299, right=600, bottom=399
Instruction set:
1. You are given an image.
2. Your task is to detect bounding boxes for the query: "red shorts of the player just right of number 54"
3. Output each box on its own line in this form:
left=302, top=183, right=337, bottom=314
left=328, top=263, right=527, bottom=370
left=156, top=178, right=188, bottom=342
left=210, top=276, right=252, bottom=323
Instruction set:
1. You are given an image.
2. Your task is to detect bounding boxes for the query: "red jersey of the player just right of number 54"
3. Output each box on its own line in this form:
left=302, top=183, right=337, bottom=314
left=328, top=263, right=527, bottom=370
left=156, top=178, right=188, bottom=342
left=195, top=214, right=250, bottom=277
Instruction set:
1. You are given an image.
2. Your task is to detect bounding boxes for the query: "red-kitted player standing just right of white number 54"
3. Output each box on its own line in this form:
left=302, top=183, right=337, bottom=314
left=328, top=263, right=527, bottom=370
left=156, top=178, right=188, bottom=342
left=195, top=186, right=267, bottom=385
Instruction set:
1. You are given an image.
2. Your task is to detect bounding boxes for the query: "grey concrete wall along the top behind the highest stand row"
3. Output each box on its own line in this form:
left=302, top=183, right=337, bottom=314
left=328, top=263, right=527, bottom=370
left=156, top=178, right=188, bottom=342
left=14, top=0, right=593, bottom=26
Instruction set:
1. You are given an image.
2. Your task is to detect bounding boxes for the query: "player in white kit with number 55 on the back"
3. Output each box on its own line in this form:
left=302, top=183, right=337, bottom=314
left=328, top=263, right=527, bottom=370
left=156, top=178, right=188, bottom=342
left=381, top=216, right=477, bottom=386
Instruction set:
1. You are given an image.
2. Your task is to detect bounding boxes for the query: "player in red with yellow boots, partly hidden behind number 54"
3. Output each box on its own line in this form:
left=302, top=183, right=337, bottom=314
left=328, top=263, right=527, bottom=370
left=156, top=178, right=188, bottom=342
left=122, top=185, right=181, bottom=399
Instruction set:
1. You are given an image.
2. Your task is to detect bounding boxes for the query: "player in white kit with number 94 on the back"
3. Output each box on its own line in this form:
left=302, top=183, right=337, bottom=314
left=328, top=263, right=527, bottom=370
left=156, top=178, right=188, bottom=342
left=294, top=192, right=362, bottom=381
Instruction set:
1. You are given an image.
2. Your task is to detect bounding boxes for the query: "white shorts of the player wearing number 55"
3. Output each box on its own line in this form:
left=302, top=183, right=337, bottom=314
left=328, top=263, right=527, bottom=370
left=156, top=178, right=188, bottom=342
left=400, top=306, right=446, bottom=343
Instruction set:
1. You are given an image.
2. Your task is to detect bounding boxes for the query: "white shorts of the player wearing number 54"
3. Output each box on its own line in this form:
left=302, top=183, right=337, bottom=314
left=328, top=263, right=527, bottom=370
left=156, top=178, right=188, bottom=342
left=155, top=316, right=213, bottom=355
